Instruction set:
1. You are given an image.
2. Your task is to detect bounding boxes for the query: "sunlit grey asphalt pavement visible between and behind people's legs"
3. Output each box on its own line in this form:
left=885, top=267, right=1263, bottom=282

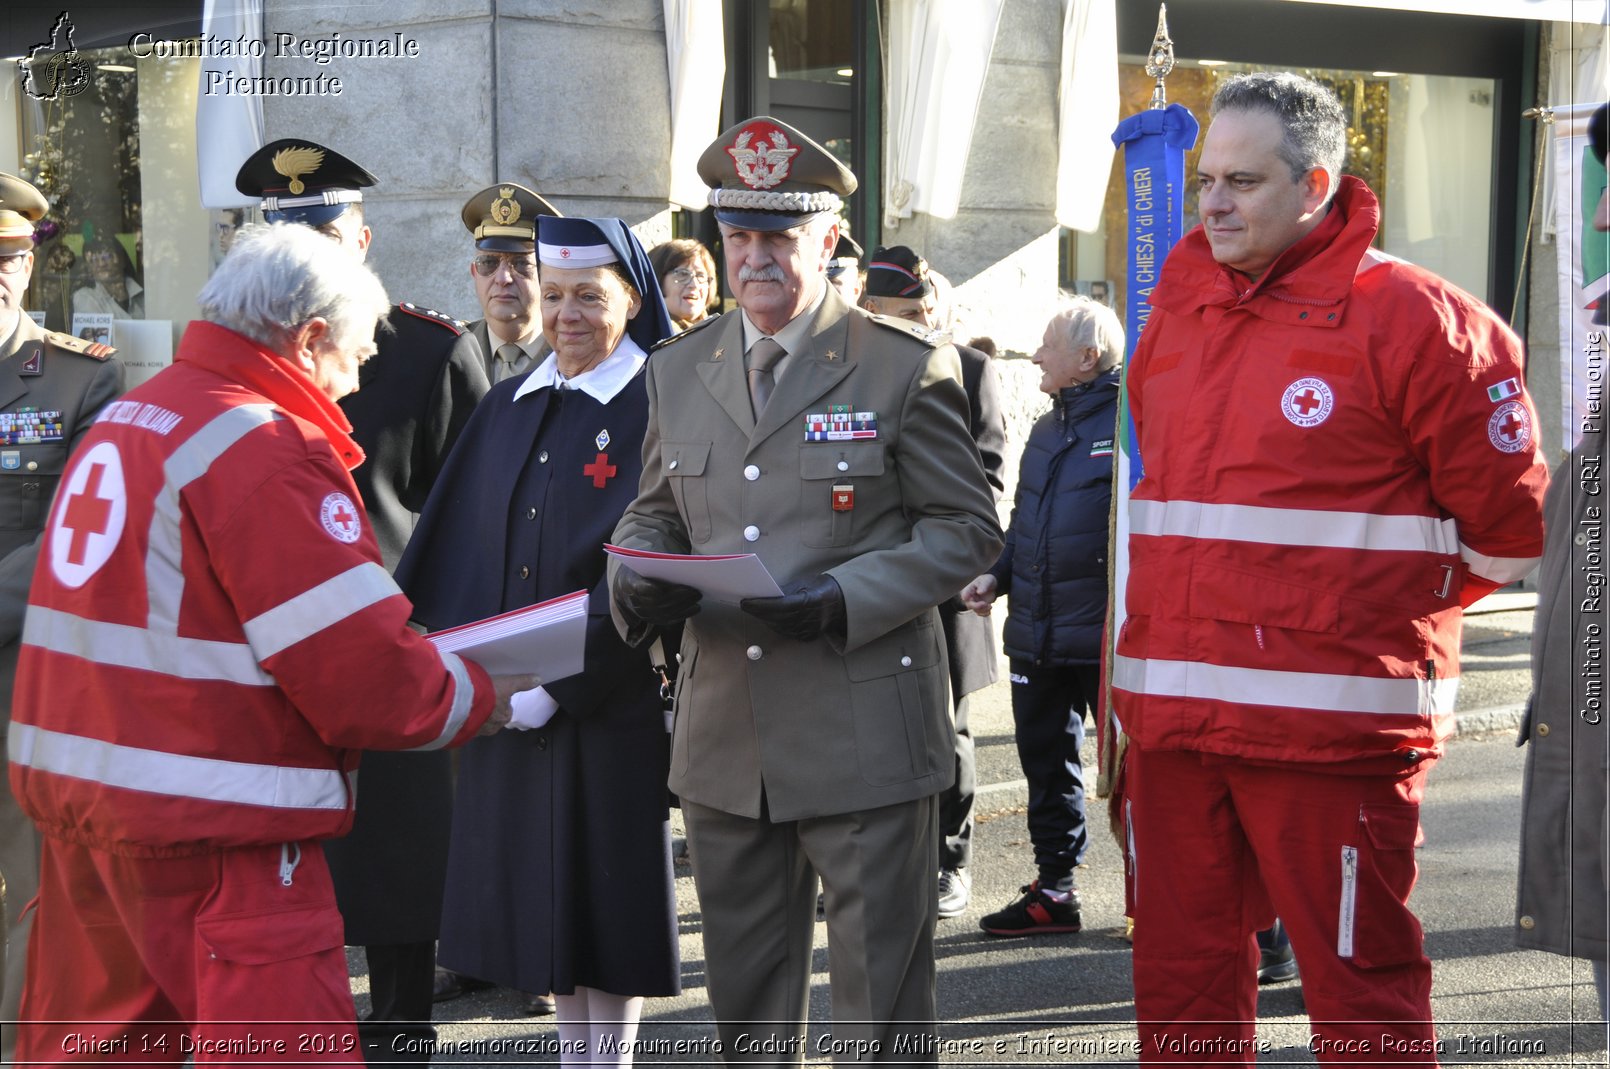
left=353, top=596, right=1605, bottom=1066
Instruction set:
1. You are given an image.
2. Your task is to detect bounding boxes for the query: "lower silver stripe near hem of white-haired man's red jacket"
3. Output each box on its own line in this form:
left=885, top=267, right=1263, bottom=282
left=8, top=723, right=348, bottom=810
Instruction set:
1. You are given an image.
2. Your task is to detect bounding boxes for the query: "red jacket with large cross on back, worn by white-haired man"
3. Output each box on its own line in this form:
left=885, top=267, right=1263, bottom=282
left=8, top=324, right=493, bottom=855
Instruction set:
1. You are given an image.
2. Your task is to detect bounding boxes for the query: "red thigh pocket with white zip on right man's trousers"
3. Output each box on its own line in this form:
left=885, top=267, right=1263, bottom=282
left=1336, top=805, right=1423, bottom=968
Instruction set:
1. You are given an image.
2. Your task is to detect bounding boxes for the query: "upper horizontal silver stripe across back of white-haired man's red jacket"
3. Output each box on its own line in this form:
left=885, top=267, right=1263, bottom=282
left=23, top=605, right=274, bottom=686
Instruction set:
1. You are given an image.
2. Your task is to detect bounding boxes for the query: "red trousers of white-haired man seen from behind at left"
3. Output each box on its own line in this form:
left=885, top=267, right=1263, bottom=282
left=16, top=837, right=364, bottom=1066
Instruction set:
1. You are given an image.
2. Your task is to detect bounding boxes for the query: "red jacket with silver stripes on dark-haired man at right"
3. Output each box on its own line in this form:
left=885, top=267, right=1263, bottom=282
left=1113, top=177, right=1547, bottom=765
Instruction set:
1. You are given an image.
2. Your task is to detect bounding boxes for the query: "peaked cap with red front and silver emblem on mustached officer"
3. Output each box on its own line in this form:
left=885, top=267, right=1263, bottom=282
left=699, top=114, right=857, bottom=230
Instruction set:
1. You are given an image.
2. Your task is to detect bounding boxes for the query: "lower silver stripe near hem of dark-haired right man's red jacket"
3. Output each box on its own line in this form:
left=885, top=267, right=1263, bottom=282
left=1113, top=657, right=1459, bottom=716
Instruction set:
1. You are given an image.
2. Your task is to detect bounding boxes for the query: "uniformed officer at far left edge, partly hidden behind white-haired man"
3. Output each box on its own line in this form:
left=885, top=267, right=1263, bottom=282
left=0, top=174, right=122, bottom=1063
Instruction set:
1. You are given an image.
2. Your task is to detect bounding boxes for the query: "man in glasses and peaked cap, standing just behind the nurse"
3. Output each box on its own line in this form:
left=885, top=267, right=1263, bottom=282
left=459, top=182, right=564, bottom=386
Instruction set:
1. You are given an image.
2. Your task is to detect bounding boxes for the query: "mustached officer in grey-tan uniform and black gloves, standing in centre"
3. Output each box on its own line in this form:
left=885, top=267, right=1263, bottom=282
left=612, top=116, right=1001, bottom=1064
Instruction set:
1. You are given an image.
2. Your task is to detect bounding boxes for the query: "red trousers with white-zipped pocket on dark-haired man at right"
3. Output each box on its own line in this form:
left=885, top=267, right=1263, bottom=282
left=1125, top=747, right=1436, bottom=1066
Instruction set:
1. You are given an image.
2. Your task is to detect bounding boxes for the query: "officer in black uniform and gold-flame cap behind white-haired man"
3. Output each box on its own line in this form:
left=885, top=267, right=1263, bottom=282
left=235, top=138, right=488, bottom=1063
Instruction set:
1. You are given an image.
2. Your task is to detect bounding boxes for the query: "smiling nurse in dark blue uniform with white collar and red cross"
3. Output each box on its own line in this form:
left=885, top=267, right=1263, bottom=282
left=405, top=217, right=679, bottom=1064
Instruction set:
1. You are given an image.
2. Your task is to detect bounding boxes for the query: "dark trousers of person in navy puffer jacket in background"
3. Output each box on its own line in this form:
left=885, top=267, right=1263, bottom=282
left=1011, top=658, right=1101, bottom=887
